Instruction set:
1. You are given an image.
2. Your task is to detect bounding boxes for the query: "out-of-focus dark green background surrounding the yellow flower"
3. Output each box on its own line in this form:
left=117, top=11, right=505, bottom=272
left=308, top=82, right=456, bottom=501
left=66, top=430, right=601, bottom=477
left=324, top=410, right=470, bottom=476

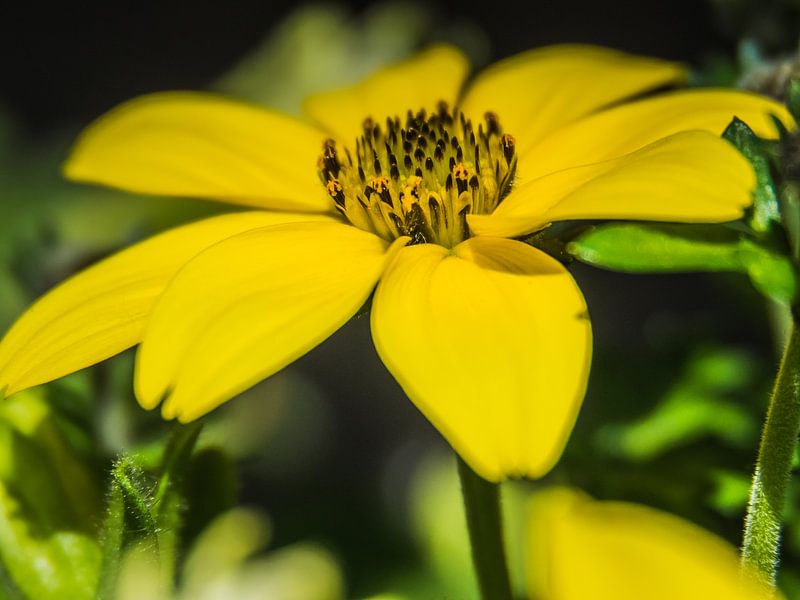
left=0, top=0, right=800, bottom=600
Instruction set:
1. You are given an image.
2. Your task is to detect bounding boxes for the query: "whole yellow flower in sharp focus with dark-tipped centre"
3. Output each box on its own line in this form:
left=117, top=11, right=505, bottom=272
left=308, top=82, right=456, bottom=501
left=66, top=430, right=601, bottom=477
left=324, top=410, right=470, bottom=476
left=0, top=46, right=791, bottom=481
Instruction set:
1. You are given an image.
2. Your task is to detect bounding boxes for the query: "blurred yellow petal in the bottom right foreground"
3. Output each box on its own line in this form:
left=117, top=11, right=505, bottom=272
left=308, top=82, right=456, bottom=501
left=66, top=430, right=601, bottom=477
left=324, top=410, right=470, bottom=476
left=528, top=489, right=777, bottom=600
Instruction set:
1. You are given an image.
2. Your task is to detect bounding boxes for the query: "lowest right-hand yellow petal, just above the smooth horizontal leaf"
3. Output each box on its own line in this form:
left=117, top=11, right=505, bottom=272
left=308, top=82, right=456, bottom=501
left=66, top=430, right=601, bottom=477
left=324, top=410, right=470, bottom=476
left=469, top=131, right=755, bottom=236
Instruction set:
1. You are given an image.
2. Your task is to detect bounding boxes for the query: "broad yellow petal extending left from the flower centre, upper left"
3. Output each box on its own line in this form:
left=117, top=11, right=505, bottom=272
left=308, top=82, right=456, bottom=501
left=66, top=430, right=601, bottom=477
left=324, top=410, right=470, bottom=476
left=64, top=92, right=333, bottom=211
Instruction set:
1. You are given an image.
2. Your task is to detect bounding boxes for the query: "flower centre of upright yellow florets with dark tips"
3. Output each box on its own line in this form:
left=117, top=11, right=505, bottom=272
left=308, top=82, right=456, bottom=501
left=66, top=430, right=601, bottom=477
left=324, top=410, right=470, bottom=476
left=318, top=102, right=517, bottom=248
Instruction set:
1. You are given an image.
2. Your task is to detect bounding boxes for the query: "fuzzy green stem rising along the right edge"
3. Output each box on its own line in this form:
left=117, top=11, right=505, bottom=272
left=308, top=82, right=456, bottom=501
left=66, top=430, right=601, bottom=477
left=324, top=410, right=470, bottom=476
left=742, top=319, right=800, bottom=585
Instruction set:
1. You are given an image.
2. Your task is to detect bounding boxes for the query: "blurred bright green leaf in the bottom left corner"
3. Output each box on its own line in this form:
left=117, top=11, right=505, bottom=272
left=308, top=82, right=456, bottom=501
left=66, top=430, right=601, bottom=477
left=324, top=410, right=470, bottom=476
left=0, top=390, right=100, bottom=600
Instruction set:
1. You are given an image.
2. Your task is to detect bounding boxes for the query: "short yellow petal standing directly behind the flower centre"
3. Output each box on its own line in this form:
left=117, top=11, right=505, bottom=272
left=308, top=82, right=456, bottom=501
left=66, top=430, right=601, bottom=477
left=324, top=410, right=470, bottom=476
left=303, top=45, right=469, bottom=144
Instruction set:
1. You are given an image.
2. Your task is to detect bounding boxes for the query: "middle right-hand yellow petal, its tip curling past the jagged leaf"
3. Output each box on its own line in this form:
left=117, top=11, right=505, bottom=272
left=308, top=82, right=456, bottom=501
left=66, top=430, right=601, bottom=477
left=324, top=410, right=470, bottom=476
left=518, top=90, right=794, bottom=182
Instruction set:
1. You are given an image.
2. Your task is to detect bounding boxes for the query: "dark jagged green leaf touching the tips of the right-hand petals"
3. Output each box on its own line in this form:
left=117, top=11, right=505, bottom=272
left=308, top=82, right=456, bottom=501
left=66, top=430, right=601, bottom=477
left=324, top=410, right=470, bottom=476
left=722, top=117, right=780, bottom=232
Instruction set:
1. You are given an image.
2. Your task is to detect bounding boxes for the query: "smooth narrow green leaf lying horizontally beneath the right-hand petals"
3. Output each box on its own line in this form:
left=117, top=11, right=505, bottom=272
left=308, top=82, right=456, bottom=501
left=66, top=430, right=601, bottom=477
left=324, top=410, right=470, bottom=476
left=567, top=223, right=741, bottom=273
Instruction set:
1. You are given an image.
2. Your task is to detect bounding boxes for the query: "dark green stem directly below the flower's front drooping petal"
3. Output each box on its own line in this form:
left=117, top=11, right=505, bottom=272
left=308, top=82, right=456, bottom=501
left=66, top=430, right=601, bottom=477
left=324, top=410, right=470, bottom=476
left=458, top=457, right=512, bottom=600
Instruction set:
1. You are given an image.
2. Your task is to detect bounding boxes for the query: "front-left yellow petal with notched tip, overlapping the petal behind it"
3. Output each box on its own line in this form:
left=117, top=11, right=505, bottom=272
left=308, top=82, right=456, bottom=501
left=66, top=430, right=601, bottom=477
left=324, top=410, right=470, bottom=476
left=135, top=223, right=406, bottom=421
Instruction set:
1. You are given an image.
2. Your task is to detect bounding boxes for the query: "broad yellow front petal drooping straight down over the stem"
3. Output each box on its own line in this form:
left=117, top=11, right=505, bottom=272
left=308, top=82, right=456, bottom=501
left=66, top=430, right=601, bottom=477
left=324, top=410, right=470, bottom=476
left=372, top=238, right=591, bottom=481
